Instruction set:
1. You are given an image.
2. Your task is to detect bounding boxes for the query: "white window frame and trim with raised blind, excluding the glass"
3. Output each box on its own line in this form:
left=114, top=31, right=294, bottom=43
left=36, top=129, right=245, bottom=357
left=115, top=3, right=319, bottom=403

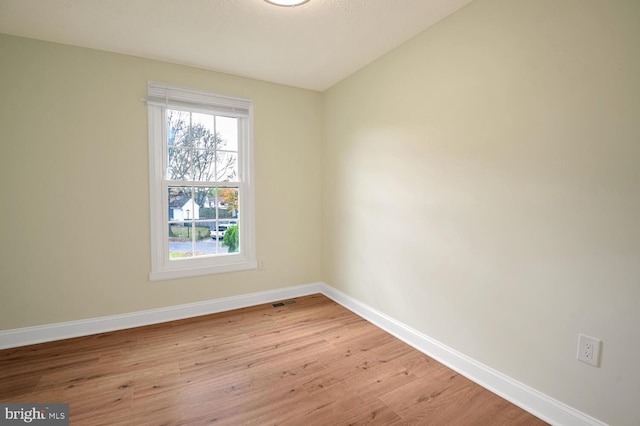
left=145, top=82, right=258, bottom=281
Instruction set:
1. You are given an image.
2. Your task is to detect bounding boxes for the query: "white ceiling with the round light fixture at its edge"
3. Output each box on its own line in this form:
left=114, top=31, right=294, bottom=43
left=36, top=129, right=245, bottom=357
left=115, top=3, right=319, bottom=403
left=0, top=0, right=472, bottom=91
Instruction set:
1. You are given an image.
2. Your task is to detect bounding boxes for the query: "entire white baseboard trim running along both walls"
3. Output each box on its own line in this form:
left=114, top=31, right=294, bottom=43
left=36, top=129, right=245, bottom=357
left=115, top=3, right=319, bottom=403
left=0, top=282, right=606, bottom=426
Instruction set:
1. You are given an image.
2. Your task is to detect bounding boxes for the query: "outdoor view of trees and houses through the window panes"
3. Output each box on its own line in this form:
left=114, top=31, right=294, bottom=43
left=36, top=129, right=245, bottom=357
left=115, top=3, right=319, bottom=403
left=166, top=109, right=241, bottom=259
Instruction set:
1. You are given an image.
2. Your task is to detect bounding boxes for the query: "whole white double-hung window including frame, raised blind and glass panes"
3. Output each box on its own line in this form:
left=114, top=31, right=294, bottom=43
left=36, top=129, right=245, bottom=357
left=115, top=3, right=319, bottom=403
left=146, top=82, right=257, bottom=281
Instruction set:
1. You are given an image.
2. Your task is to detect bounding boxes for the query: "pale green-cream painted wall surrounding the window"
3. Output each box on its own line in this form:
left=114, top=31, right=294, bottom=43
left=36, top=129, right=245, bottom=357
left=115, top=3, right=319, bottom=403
left=0, top=35, right=322, bottom=330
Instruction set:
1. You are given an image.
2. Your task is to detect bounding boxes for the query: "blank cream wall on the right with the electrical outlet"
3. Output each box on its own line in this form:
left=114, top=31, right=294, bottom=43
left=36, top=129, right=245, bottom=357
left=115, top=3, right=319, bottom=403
left=323, top=0, right=640, bottom=425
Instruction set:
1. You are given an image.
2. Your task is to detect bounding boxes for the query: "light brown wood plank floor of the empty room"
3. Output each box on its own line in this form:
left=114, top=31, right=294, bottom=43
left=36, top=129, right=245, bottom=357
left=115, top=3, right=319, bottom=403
left=0, top=295, right=545, bottom=426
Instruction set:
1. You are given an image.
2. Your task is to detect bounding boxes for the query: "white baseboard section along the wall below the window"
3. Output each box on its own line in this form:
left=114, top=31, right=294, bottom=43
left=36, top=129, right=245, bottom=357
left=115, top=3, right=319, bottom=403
left=0, top=283, right=323, bottom=349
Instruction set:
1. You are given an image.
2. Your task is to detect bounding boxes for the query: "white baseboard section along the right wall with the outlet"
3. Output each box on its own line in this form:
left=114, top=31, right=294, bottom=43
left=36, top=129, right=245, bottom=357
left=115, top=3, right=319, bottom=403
left=322, top=284, right=606, bottom=426
